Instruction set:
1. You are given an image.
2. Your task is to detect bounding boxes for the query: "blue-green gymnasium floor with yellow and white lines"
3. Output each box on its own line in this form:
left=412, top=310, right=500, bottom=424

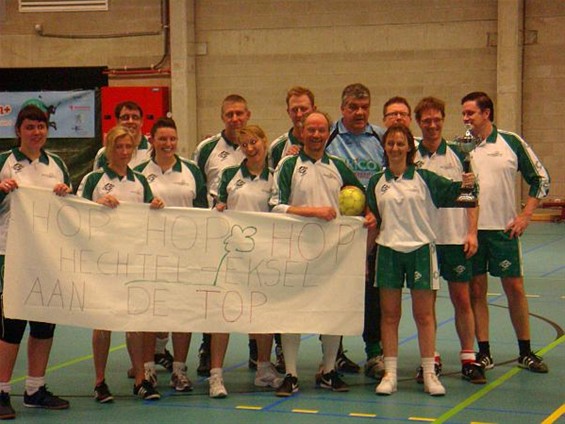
left=5, top=223, right=565, bottom=424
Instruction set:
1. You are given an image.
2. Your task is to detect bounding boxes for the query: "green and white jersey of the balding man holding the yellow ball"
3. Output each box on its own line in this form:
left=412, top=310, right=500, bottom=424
left=269, top=151, right=365, bottom=214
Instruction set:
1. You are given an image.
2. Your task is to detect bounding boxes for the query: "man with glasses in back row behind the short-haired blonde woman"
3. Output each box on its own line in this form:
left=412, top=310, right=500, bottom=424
left=92, top=100, right=151, bottom=171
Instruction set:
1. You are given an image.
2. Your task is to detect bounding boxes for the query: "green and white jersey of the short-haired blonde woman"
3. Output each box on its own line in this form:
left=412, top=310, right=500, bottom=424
left=77, top=165, right=153, bottom=203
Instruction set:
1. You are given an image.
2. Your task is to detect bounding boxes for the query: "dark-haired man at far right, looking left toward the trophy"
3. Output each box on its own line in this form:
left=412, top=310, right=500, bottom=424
left=461, top=92, right=550, bottom=373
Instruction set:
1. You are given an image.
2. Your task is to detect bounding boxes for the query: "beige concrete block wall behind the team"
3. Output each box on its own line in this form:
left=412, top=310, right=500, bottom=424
left=0, top=0, right=565, bottom=197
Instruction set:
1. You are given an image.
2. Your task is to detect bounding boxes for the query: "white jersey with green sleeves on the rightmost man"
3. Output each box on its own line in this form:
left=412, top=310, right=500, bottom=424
left=471, top=126, right=550, bottom=230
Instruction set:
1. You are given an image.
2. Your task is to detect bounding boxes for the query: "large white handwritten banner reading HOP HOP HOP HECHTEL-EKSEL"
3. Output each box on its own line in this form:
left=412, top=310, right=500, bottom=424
left=4, top=187, right=367, bottom=335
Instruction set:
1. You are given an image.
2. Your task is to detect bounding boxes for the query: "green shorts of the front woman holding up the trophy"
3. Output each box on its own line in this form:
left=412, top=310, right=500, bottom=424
left=375, top=244, right=439, bottom=290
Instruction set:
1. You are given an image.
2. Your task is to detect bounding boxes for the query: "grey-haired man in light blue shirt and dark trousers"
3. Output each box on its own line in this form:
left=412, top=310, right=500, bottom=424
left=326, top=83, right=384, bottom=380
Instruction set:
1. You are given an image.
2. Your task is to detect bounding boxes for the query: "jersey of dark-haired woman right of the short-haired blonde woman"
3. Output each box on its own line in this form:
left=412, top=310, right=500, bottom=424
left=135, top=155, right=208, bottom=208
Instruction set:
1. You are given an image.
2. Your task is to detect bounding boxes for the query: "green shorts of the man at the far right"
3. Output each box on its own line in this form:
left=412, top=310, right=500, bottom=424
left=471, top=230, right=524, bottom=277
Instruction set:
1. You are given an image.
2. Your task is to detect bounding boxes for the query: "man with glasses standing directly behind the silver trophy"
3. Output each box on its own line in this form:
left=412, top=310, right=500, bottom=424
left=414, top=97, right=486, bottom=384
